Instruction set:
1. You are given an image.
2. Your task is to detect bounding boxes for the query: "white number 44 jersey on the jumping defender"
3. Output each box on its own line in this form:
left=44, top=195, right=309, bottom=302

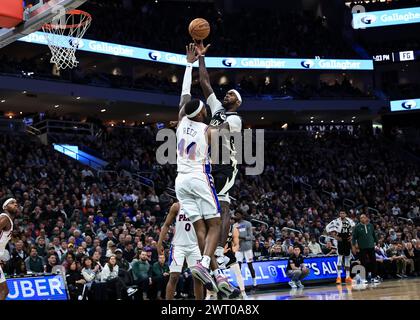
left=176, top=117, right=211, bottom=174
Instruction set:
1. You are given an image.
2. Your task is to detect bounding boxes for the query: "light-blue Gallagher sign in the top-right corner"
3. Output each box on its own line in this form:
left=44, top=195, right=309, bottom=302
left=353, top=7, right=420, bottom=29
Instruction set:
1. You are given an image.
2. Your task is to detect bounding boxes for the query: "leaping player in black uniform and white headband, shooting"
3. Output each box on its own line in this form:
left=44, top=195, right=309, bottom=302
left=196, top=40, right=242, bottom=276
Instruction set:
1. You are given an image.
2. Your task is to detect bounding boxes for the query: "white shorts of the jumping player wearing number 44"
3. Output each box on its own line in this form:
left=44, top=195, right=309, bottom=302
left=175, top=172, right=220, bottom=223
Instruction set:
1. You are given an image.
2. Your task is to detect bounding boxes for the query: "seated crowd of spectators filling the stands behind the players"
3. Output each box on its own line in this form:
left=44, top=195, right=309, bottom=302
left=0, top=121, right=420, bottom=300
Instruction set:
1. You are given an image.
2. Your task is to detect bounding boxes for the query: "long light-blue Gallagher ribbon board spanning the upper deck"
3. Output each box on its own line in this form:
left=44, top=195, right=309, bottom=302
left=19, top=32, right=373, bottom=70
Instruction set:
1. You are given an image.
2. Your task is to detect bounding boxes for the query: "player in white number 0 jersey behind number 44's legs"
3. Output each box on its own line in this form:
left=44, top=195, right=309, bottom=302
left=157, top=202, right=204, bottom=300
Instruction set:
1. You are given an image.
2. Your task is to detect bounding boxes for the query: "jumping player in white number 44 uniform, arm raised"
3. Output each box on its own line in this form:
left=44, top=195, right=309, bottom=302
left=175, top=43, right=239, bottom=297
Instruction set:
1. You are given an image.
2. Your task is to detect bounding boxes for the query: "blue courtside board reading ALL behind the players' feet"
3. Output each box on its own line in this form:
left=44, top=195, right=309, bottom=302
left=225, top=256, right=337, bottom=286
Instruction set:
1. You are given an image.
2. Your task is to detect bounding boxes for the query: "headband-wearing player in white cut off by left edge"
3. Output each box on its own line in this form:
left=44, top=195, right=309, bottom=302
left=0, top=198, right=18, bottom=300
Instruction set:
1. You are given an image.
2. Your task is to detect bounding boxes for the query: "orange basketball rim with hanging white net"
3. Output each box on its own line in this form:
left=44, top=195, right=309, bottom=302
left=42, top=10, right=92, bottom=69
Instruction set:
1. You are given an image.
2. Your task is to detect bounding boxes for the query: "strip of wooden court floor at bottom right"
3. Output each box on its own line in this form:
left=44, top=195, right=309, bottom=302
left=244, top=278, right=420, bottom=300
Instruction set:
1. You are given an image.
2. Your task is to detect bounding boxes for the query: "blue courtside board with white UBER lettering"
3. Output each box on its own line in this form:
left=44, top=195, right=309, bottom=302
left=6, top=275, right=68, bottom=300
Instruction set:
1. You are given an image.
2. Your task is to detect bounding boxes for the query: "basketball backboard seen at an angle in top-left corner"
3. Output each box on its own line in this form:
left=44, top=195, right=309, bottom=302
left=0, top=0, right=87, bottom=48
